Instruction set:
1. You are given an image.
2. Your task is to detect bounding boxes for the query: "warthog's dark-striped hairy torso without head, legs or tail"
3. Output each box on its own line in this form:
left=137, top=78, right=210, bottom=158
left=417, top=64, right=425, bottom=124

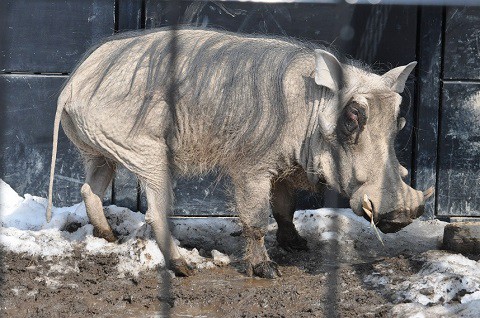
left=59, top=29, right=313, bottom=174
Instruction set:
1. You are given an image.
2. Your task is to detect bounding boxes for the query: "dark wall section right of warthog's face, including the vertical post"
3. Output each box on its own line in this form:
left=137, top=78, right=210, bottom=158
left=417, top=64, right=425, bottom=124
left=413, top=7, right=480, bottom=217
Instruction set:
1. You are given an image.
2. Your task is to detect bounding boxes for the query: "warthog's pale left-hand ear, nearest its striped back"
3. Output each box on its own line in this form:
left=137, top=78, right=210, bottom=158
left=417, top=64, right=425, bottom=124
left=315, top=49, right=343, bottom=93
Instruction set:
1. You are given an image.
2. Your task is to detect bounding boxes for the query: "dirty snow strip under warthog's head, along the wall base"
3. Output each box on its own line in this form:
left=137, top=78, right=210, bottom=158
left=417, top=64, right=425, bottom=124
left=294, top=208, right=447, bottom=262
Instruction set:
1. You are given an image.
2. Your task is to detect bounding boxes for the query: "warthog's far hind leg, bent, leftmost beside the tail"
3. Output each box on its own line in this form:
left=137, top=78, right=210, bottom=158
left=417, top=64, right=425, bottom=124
left=81, top=157, right=116, bottom=242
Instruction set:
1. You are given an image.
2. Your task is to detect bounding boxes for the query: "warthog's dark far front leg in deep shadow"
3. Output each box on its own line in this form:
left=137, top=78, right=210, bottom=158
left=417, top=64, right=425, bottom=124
left=271, top=179, right=308, bottom=251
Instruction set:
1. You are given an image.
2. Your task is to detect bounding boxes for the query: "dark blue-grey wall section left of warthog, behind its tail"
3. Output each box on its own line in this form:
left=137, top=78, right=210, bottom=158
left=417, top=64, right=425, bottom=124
left=0, top=0, right=115, bottom=204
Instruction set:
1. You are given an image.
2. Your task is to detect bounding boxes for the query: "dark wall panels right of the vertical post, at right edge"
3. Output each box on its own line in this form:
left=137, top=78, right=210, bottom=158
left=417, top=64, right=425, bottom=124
left=437, top=7, right=480, bottom=216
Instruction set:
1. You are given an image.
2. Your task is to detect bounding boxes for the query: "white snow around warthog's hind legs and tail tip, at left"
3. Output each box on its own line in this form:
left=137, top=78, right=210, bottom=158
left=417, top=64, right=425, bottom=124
left=0, top=179, right=232, bottom=276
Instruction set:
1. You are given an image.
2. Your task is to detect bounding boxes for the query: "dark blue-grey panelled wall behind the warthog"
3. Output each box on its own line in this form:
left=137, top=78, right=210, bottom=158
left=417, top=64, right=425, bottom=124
left=0, top=0, right=480, bottom=216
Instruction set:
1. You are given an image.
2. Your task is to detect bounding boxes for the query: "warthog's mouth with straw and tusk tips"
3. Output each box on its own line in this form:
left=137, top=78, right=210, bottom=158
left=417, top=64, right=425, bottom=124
left=362, top=187, right=434, bottom=233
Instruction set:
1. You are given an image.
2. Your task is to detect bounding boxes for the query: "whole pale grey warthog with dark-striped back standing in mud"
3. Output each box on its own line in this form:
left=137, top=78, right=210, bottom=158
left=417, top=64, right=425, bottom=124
left=47, top=29, right=424, bottom=278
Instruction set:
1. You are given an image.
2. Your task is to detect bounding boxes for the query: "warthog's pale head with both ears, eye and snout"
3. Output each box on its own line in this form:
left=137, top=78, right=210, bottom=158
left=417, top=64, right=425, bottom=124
left=313, top=50, right=434, bottom=233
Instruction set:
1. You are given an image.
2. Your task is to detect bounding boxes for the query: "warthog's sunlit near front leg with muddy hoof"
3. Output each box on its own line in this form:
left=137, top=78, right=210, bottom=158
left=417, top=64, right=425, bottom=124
left=234, top=177, right=281, bottom=278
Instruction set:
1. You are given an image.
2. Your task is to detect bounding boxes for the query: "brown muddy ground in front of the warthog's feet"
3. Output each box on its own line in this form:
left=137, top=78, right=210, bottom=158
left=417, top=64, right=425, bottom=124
left=0, top=238, right=428, bottom=317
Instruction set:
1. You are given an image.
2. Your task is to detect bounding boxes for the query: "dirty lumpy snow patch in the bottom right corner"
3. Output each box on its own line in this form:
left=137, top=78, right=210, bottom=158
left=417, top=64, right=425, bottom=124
left=365, top=250, right=480, bottom=317
